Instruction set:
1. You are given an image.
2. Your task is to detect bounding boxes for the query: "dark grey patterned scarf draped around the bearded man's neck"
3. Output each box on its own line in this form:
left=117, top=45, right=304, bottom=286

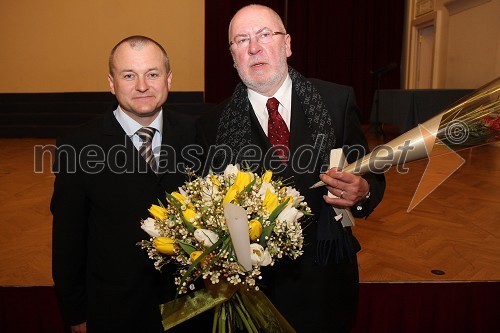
left=215, top=67, right=359, bottom=266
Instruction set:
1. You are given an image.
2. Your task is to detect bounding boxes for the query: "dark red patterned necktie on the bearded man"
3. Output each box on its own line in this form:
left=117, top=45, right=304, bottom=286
left=266, top=97, right=290, bottom=159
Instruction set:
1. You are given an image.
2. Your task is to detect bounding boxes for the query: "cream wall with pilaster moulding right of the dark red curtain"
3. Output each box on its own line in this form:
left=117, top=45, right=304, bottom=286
left=403, top=0, right=500, bottom=89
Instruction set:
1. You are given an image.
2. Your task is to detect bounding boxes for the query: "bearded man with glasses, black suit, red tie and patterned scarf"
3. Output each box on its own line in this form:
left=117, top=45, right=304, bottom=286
left=198, top=5, right=385, bottom=333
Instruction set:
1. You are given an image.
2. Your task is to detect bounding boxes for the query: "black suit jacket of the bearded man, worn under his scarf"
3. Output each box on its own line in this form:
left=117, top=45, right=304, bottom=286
left=197, top=79, right=385, bottom=332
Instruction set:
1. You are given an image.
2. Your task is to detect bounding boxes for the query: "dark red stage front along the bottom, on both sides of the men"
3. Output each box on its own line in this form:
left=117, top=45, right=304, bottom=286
left=0, top=281, right=500, bottom=333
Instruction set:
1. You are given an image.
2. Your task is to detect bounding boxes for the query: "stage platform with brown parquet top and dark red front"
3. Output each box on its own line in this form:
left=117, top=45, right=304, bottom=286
left=0, top=133, right=500, bottom=333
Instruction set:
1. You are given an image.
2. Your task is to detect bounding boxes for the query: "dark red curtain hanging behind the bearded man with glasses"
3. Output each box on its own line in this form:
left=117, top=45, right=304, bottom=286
left=205, top=0, right=405, bottom=122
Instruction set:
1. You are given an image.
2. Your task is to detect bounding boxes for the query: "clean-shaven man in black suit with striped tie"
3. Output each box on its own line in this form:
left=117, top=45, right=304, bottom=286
left=51, top=36, right=194, bottom=333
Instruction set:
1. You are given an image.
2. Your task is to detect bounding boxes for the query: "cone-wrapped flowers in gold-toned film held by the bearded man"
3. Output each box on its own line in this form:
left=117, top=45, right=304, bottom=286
left=311, top=77, right=500, bottom=188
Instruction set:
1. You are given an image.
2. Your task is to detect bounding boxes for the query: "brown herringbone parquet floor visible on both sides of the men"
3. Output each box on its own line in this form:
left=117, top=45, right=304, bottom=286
left=0, top=135, right=500, bottom=286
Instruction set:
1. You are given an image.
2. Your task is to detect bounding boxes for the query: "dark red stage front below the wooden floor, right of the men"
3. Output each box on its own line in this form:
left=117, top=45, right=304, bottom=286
left=351, top=280, right=500, bottom=333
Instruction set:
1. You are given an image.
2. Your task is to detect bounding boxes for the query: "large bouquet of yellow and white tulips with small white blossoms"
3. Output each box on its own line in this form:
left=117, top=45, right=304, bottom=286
left=140, top=165, right=310, bottom=332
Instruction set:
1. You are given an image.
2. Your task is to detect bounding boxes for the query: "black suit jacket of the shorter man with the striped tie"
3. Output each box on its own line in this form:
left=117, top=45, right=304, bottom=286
left=51, top=110, right=194, bottom=332
